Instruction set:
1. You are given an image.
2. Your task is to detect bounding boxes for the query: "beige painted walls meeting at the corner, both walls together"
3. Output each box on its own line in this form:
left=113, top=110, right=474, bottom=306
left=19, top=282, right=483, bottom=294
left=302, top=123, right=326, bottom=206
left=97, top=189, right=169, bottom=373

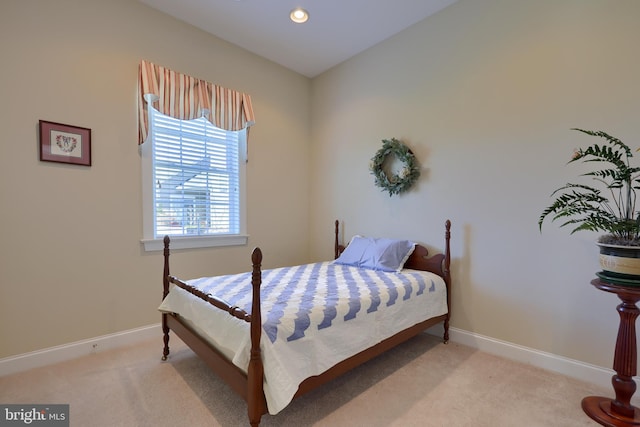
left=0, top=0, right=640, bottom=374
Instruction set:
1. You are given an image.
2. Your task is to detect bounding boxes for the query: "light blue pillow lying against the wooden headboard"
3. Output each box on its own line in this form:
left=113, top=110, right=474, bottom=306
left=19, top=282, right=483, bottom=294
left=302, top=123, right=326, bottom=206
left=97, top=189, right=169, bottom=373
left=334, top=236, right=416, bottom=272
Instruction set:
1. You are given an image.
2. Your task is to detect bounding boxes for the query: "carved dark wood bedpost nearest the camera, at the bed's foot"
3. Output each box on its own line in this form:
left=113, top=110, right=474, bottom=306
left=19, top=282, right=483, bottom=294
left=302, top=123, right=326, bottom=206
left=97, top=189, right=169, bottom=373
left=247, top=248, right=265, bottom=426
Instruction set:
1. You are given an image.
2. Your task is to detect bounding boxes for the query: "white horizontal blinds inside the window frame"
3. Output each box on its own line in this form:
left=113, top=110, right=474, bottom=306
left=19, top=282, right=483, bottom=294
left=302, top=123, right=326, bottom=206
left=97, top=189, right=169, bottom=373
left=150, top=108, right=245, bottom=238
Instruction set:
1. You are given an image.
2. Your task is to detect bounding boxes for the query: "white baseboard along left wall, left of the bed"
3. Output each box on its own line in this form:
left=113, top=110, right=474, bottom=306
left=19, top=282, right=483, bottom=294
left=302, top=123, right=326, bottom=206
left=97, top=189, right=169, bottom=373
left=0, top=323, right=162, bottom=377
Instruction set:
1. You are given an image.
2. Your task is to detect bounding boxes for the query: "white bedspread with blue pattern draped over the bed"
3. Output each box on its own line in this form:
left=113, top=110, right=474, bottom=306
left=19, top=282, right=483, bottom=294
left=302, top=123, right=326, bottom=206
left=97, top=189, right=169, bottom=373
left=159, top=262, right=447, bottom=414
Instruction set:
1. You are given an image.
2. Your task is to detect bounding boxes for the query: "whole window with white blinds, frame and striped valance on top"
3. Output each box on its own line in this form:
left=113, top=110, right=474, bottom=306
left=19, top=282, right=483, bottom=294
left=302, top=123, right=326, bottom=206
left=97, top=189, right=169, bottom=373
left=138, top=60, right=255, bottom=250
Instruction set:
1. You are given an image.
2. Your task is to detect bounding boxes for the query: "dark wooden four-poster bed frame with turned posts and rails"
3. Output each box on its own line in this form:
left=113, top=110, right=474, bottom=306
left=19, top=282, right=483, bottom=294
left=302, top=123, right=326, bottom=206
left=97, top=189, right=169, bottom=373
left=162, top=220, right=451, bottom=426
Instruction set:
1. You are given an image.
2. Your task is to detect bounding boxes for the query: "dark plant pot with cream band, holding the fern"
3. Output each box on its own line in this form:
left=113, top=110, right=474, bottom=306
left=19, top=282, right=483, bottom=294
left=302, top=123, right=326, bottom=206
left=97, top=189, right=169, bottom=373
left=598, top=243, right=640, bottom=286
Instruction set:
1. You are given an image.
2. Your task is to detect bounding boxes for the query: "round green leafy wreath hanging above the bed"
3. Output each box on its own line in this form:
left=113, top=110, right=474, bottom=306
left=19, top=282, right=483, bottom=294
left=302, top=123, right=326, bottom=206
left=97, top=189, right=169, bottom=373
left=369, top=138, right=420, bottom=197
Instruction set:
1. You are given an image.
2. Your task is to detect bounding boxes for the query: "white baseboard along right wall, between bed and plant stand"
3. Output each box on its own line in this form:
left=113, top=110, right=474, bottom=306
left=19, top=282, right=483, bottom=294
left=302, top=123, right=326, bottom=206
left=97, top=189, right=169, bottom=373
left=427, top=327, right=616, bottom=388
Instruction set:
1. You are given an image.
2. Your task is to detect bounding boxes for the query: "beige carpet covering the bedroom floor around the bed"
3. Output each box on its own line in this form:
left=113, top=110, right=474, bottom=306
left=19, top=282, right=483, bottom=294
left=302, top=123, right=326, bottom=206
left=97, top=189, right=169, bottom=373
left=0, top=334, right=624, bottom=427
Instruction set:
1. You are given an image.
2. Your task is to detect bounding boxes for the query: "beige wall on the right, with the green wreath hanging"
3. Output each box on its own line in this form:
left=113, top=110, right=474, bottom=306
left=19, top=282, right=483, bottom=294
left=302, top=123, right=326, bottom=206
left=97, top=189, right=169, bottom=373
left=311, top=0, right=640, bottom=367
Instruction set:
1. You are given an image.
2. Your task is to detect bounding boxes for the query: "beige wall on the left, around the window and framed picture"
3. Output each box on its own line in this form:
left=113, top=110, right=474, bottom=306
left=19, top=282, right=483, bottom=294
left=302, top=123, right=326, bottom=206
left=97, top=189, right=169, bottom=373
left=0, top=0, right=310, bottom=358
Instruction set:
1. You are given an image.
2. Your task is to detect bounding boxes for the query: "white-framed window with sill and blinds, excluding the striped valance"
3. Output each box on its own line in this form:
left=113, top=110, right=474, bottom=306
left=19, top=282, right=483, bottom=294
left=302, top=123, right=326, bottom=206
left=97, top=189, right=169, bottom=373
left=142, top=106, right=247, bottom=250
